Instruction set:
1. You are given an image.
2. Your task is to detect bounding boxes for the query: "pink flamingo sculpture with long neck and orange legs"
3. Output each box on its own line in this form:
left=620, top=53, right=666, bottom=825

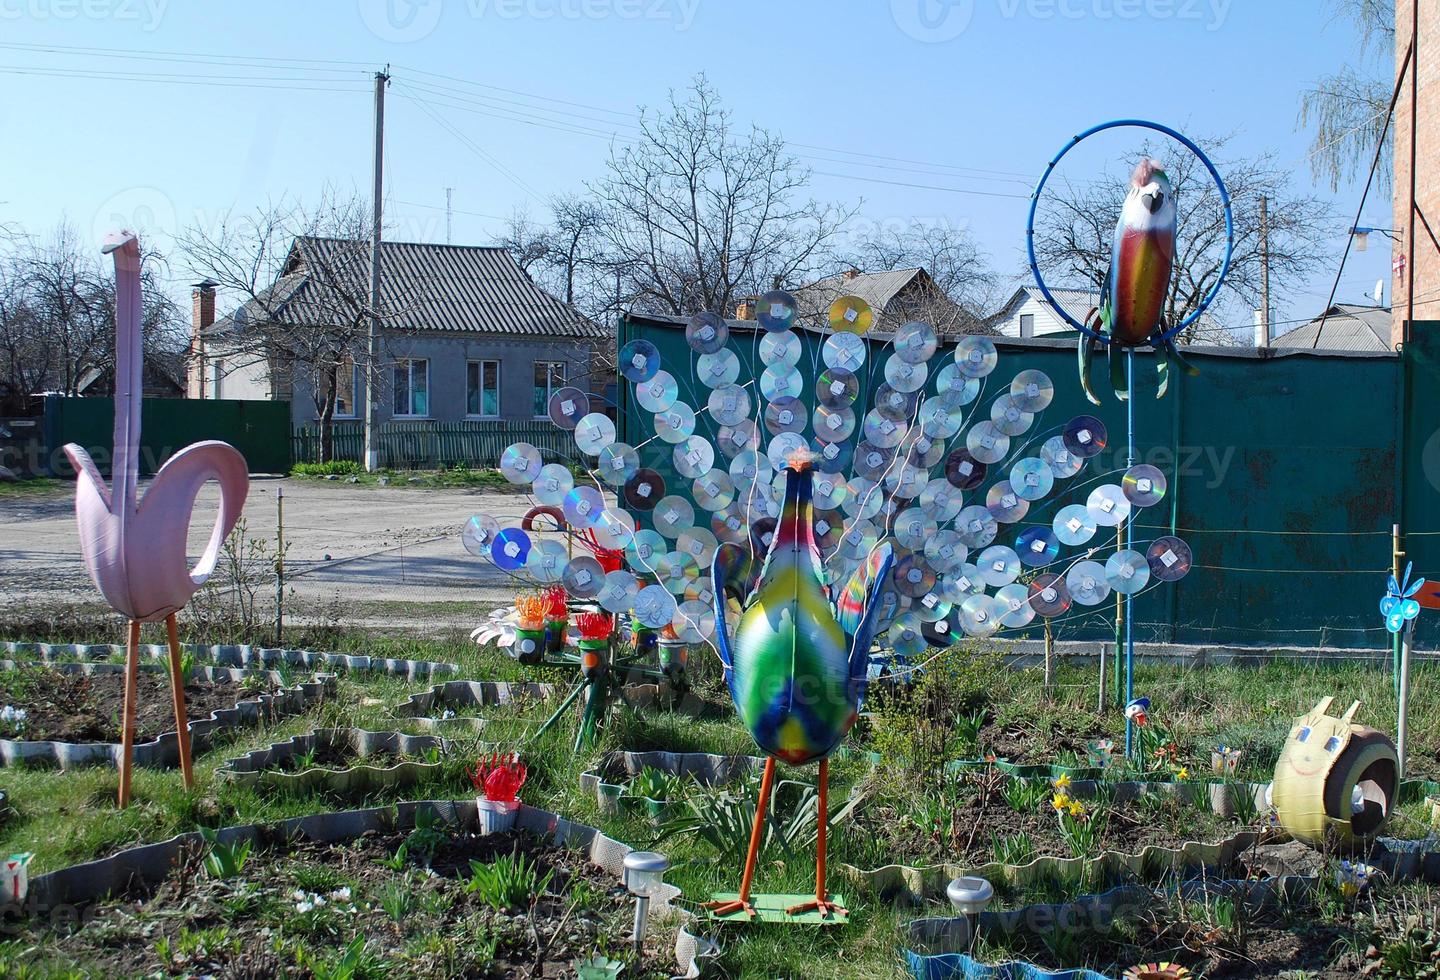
left=65, top=232, right=249, bottom=807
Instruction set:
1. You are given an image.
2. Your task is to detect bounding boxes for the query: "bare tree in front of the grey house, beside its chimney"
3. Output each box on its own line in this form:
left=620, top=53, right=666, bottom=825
left=179, top=191, right=423, bottom=460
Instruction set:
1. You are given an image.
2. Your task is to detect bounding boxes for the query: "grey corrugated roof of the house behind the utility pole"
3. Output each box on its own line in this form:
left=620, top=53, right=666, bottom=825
left=208, top=237, right=611, bottom=338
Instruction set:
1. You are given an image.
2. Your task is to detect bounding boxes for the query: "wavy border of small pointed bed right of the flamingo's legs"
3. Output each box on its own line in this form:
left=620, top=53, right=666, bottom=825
left=215, top=728, right=454, bottom=794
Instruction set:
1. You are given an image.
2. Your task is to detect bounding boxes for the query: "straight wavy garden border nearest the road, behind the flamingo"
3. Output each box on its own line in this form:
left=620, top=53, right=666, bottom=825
left=0, top=640, right=461, bottom=681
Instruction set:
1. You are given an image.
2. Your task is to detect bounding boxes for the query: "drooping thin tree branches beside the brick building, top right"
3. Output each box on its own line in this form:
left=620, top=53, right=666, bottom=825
left=1297, top=0, right=1388, bottom=191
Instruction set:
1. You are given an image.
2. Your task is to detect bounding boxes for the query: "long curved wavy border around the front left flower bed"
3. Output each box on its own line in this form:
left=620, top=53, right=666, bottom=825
left=20, top=800, right=717, bottom=977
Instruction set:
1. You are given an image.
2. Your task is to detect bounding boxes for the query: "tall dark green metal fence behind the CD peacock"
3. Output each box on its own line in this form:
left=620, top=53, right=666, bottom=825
left=619, top=317, right=1405, bottom=649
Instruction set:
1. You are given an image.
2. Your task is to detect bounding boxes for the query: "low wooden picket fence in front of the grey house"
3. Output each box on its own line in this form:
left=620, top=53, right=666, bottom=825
left=291, top=420, right=576, bottom=469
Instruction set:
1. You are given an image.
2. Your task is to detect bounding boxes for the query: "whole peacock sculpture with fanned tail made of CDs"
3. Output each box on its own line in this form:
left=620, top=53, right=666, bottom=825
left=465, top=289, right=1192, bottom=921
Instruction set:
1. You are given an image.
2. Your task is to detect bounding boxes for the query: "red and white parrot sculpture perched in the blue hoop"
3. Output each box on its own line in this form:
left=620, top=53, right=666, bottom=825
left=1079, top=157, right=1194, bottom=404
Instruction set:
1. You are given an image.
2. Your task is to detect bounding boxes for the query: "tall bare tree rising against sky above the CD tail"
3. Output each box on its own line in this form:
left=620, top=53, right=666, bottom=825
left=590, top=75, right=854, bottom=320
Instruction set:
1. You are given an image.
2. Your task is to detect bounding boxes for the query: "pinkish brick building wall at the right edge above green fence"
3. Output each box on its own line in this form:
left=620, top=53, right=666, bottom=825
left=1390, top=0, right=1440, bottom=344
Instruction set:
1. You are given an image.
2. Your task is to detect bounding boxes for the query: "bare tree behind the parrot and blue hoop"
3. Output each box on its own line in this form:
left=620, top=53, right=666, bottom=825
left=1035, top=137, right=1332, bottom=344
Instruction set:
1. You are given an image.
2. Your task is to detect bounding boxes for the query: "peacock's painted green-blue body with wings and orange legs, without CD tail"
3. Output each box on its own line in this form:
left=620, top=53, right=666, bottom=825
left=711, top=459, right=893, bottom=918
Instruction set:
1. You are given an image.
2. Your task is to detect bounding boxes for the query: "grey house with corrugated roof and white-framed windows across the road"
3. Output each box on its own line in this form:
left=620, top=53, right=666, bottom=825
left=189, top=237, right=613, bottom=427
